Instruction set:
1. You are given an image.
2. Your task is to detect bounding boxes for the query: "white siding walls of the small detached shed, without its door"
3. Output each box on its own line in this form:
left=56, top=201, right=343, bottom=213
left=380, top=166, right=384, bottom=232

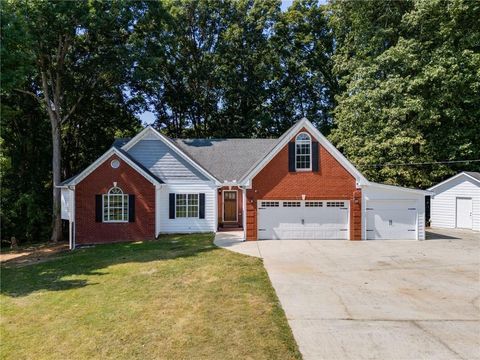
left=430, top=175, right=480, bottom=231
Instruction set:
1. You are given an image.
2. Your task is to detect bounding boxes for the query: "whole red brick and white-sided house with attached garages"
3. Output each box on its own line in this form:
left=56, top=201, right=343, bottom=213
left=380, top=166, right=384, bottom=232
left=60, top=119, right=429, bottom=248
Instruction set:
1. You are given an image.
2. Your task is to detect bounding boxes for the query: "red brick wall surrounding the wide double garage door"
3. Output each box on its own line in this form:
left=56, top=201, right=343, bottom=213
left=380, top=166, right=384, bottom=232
left=247, top=130, right=361, bottom=240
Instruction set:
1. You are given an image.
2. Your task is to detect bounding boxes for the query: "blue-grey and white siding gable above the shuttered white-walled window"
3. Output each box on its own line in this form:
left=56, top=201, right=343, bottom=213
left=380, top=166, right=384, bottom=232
left=128, top=140, right=209, bottom=182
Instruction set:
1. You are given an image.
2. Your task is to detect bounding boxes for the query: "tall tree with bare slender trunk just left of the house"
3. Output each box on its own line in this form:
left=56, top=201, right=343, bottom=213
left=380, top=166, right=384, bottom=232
left=2, top=0, right=141, bottom=241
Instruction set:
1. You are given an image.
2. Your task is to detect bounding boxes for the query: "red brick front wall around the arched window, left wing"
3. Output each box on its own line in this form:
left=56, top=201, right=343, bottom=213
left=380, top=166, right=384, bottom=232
left=75, top=155, right=155, bottom=244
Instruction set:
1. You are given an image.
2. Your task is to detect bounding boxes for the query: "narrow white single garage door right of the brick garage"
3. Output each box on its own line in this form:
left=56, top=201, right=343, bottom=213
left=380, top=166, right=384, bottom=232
left=366, top=200, right=417, bottom=240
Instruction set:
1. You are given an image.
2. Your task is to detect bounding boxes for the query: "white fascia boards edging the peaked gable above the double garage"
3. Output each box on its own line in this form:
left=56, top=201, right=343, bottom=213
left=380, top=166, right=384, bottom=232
left=239, top=118, right=369, bottom=185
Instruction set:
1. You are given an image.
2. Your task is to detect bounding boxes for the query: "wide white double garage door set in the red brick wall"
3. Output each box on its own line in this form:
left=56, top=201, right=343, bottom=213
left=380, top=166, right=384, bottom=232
left=258, top=200, right=349, bottom=240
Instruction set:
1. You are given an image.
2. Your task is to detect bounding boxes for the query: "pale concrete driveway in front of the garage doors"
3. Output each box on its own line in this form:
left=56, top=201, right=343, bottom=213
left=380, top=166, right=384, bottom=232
left=218, top=230, right=480, bottom=360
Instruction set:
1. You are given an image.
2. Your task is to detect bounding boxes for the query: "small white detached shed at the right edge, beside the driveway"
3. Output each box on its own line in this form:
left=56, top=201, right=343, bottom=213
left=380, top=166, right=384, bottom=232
left=428, top=171, right=480, bottom=231
